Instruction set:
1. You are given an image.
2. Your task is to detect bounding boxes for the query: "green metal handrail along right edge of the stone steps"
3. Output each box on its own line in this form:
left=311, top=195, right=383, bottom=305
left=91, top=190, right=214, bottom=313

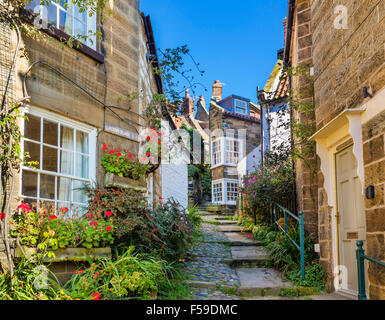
left=271, top=202, right=305, bottom=280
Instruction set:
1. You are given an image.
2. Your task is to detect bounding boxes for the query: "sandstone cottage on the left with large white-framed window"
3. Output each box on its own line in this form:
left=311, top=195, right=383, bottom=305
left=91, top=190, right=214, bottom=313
left=0, top=0, right=171, bottom=216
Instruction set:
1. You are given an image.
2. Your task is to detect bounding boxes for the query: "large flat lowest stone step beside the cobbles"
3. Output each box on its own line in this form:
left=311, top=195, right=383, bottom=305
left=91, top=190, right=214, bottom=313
left=236, top=268, right=292, bottom=297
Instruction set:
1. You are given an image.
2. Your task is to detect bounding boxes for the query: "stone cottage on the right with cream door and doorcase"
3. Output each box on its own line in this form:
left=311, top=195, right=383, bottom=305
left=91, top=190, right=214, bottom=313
left=284, top=0, right=385, bottom=299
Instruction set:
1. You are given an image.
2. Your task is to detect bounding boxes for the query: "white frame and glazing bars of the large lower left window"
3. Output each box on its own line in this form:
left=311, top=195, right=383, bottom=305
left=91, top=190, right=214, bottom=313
left=19, top=106, right=97, bottom=215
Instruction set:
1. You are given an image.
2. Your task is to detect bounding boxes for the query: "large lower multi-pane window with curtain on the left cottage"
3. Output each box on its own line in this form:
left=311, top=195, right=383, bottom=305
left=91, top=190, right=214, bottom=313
left=21, top=109, right=96, bottom=214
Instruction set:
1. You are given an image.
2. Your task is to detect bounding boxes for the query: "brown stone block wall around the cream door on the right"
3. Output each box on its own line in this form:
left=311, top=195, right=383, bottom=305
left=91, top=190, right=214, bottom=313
left=304, top=0, right=385, bottom=299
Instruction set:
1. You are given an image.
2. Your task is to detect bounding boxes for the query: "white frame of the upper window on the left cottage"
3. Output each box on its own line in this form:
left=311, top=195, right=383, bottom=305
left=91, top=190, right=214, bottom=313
left=30, top=0, right=97, bottom=50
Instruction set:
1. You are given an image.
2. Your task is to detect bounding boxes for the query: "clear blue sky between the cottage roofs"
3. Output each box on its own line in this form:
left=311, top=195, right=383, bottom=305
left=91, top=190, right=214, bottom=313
left=140, top=0, right=287, bottom=107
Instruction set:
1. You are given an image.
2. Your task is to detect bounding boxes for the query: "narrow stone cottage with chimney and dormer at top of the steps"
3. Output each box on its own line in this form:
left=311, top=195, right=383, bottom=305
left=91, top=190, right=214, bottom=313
left=210, top=80, right=262, bottom=208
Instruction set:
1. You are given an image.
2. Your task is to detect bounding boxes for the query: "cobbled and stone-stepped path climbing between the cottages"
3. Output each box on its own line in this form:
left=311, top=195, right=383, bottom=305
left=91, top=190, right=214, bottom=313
left=177, top=211, right=352, bottom=300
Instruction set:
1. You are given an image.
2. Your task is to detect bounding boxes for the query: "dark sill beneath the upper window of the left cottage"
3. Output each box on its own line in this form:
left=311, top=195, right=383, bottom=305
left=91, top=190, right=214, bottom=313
left=21, top=9, right=104, bottom=64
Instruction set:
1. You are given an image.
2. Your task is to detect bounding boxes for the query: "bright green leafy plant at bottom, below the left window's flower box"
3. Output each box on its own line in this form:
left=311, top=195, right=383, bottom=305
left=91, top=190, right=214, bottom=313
left=65, top=247, right=172, bottom=300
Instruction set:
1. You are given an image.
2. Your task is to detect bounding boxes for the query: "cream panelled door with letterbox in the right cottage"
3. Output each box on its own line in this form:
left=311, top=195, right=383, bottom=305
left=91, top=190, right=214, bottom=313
left=336, top=146, right=366, bottom=295
